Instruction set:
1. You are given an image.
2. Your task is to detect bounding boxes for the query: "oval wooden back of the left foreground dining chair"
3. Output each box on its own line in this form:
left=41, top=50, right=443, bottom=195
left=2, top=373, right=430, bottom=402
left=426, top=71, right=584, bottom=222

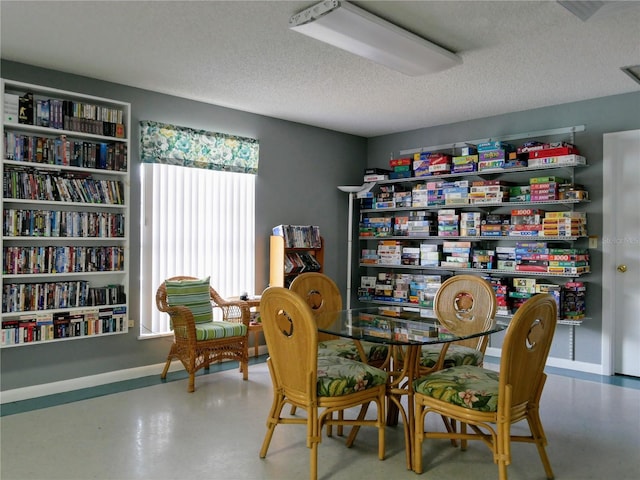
left=260, top=287, right=318, bottom=406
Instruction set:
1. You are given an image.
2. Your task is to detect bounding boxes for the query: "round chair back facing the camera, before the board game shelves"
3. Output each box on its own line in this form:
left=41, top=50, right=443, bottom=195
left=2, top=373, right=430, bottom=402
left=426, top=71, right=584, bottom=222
left=433, top=275, right=497, bottom=353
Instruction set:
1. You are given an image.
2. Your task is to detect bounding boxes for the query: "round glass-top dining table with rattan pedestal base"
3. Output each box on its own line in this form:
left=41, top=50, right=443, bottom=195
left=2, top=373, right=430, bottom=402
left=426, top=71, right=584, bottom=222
left=316, top=306, right=507, bottom=470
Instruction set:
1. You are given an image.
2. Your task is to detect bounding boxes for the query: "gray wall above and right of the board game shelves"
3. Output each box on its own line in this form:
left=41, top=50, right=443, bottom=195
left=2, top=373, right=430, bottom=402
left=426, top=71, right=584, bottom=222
left=367, top=92, right=640, bottom=364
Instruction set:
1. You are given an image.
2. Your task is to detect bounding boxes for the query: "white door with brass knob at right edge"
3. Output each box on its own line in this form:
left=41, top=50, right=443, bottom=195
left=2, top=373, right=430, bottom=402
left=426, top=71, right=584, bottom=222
left=602, top=130, right=640, bottom=377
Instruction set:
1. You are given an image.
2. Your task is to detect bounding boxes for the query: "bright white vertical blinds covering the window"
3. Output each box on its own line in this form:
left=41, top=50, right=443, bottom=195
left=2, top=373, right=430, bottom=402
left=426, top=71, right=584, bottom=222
left=140, top=163, right=256, bottom=335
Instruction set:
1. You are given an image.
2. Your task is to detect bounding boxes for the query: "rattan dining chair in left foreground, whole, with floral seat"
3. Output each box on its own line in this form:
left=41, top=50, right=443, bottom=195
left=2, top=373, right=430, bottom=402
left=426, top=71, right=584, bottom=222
left=260, top=287, right=387, bottom=480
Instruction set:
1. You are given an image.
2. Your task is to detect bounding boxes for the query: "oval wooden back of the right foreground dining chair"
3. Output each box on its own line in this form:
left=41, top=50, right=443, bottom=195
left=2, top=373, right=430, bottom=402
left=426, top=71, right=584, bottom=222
left=500, top=293, right=557, bottom=409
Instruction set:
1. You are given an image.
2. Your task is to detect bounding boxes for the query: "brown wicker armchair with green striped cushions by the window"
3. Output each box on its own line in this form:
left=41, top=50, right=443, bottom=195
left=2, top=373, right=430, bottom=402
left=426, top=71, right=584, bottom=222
left=156, top=276, right=250, bottom=392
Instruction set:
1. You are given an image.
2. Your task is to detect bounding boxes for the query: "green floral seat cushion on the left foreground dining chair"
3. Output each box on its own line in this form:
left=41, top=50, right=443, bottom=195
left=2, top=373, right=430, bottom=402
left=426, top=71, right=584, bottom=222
left=317, top=355, right=387, bottom=397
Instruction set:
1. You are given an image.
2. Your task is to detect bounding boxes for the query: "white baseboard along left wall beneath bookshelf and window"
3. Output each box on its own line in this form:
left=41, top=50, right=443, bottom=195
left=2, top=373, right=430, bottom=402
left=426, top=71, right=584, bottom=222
left=0, top=345, right=267, bottom=404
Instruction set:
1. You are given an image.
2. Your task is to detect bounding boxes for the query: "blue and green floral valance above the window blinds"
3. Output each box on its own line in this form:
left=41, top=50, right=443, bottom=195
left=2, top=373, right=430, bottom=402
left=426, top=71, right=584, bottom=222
left=140, top=120, right=260, bottom=175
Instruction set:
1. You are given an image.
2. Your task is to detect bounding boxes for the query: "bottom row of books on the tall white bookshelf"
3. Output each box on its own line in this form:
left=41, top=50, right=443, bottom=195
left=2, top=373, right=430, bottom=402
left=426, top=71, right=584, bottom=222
left=1, top=306, right=127, bottom=345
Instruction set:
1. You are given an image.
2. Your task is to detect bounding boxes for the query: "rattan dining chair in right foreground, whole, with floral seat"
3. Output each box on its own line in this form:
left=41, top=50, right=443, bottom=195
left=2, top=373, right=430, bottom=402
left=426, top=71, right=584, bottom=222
left=413, top=294, right=557, bottom=480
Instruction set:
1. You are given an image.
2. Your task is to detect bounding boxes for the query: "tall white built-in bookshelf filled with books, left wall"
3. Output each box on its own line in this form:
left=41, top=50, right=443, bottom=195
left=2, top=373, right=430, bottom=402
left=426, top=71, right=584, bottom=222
left=0, top=80, right=131, bottom=348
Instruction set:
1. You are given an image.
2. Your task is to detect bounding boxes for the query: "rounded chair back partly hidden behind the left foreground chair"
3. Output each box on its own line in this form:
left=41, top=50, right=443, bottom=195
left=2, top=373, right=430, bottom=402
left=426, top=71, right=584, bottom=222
left=289, top=272, right=342, bottom=341
